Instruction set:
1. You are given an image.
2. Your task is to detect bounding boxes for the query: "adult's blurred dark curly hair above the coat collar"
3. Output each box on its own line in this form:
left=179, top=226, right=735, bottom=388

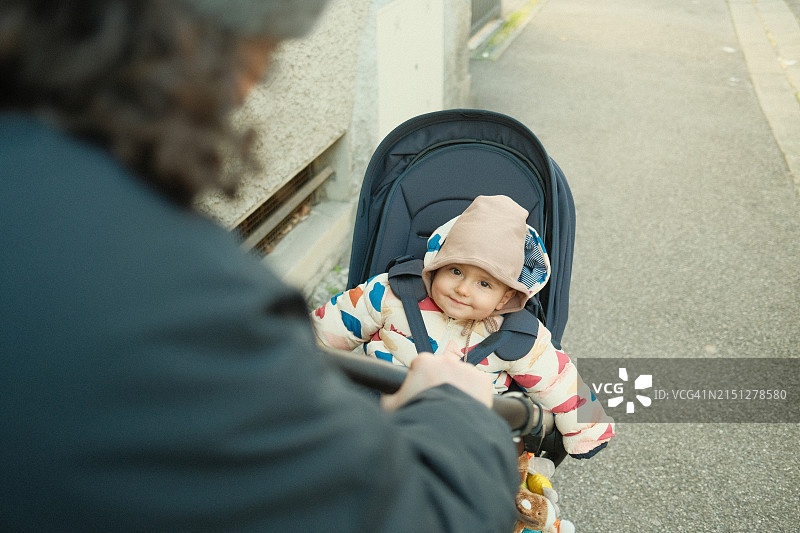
left=0, top=0, right=255, bottom=205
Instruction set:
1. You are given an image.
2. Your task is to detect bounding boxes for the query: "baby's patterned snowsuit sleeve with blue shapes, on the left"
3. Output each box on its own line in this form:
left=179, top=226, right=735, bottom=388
left=311, top=274, right=389, bottom=350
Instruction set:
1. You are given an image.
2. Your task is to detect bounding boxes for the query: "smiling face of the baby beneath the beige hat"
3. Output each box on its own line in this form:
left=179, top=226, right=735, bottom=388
left=431, top=263, right=516, bottom=320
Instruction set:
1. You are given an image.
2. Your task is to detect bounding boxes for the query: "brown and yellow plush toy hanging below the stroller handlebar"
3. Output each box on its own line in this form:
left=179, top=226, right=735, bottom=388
left=513, top=452, right=575, bottom=533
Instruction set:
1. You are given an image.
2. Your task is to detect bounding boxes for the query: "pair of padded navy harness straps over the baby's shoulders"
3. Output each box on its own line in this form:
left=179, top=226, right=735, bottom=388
left=389, top=256, right=539, bottom=365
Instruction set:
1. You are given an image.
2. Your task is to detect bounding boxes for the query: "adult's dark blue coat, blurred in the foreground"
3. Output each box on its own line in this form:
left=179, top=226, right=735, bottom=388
left=0, top=114, right=517, bottom=532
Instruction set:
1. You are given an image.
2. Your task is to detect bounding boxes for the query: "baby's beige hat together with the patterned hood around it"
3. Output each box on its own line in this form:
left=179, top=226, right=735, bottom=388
left=422, top=196, right=550, bottom=314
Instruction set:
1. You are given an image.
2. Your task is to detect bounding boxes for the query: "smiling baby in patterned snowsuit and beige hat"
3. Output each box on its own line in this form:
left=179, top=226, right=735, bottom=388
left=311, top=196, right=614, bottom=531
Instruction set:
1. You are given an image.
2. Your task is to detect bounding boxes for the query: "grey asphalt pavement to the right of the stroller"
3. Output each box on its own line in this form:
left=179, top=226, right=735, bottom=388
left=471, top=0, right=800, bottom=532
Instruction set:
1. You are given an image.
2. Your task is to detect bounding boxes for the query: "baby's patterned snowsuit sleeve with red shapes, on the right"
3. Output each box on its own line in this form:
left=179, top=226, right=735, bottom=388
left=509, top=323, right=615, bottom=457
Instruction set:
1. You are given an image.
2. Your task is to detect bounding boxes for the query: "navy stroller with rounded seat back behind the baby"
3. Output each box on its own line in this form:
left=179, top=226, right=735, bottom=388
left=347, top=109, right=575, bottom=464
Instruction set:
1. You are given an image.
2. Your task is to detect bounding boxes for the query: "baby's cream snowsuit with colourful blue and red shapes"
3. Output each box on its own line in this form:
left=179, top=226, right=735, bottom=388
left=311, top=202, right=614, bottom=455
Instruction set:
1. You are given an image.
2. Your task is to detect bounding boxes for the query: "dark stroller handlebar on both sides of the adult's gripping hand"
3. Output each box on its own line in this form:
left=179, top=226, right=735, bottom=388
left=324, top=349, right=555, bottom=436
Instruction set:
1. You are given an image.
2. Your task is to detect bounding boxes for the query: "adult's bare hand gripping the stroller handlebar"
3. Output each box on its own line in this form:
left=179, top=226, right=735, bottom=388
left=381, top=353, right=494, bottom=412
